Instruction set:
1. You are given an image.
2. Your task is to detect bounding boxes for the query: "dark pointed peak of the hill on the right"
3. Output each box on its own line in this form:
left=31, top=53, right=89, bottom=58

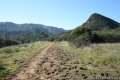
left=80, top=13, right=119, bottom=30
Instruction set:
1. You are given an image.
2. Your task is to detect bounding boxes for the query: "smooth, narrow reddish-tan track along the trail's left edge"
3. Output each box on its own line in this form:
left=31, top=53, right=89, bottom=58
left=11, top=44, right=52, bottom=80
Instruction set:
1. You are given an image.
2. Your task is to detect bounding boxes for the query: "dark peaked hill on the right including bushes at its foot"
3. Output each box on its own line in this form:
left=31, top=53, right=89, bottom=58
left=52, top=13, right=120, bottom=45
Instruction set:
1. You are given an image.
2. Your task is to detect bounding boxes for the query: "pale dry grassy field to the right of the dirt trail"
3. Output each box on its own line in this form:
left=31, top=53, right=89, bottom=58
left=61, top=42, right=120, bottom=76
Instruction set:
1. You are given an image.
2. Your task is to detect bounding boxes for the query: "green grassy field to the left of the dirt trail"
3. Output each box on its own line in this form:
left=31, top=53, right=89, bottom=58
left=0, top=42, right=48, bottom=80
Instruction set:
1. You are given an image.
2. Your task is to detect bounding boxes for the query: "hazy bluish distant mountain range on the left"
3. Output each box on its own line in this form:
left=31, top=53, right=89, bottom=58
left=0, top=22, right=65, bottom=43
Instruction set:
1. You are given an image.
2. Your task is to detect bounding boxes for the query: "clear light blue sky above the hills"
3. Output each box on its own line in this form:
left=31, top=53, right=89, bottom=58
left=0, top=0, right=120, bottom=30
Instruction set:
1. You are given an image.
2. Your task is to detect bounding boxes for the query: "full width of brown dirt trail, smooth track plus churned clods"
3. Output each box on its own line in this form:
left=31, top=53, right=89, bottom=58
left=11, top=43, right=83, bottom=80
